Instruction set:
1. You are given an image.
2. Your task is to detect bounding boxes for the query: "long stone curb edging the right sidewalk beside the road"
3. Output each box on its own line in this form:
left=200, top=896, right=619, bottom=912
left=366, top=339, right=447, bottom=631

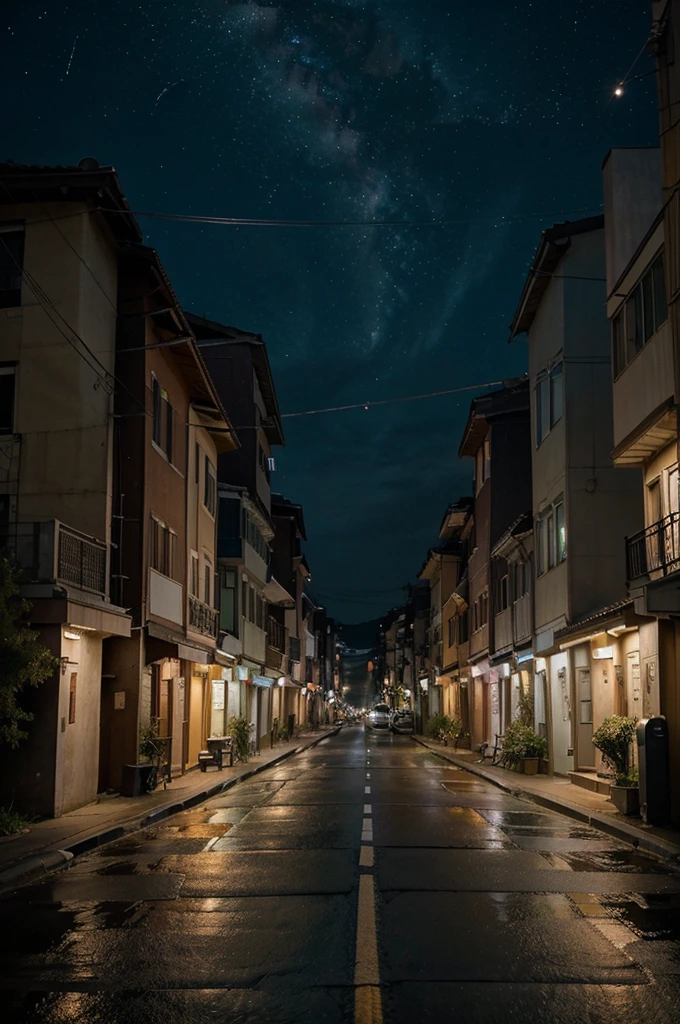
left=411, top=735, right=680, bottom=866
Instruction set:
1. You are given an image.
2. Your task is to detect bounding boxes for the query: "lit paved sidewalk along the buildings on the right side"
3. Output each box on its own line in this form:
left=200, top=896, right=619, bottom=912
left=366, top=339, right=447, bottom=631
left=412, top=736, right=680, bottom=864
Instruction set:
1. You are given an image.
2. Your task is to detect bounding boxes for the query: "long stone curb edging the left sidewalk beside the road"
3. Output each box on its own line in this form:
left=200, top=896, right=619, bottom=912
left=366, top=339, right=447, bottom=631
left=0, top=726, right=340, bottom=889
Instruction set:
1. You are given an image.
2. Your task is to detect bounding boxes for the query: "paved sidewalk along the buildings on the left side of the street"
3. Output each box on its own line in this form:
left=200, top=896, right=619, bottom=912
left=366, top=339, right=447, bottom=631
left=0, top=726, right=339, bottom=887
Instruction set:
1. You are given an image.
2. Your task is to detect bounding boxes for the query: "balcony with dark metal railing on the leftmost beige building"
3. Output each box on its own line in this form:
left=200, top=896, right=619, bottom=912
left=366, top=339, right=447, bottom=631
left=0, top=519, right=107, bottom=598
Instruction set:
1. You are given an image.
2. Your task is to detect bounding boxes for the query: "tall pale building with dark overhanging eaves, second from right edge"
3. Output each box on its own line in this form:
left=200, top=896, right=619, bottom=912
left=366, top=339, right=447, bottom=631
left=511, top=217, right=642, bottom=775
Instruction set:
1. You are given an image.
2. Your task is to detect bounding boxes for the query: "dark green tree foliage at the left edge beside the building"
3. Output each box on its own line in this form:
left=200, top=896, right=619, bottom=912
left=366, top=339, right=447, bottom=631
left=0, top=556, right=59, bottom=748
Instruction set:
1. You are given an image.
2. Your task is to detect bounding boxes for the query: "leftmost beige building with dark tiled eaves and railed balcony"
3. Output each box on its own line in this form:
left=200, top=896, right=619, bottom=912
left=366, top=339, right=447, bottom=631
left=0, top=162, right=134, bottom=816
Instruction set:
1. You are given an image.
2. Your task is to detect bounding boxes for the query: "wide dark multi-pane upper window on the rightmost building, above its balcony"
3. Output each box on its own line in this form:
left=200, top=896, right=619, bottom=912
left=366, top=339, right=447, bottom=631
left=611, top=253, right=668, bottom=378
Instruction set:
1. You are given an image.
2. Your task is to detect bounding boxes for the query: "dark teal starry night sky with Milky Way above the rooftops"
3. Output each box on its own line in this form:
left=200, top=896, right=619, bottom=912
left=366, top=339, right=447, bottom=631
left=0, top=0, right=657, bottom=622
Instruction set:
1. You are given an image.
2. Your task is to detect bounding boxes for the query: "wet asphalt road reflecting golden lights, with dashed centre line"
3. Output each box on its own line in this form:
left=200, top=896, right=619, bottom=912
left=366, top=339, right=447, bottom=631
left=0, top=726, right=680, bottom=1024
